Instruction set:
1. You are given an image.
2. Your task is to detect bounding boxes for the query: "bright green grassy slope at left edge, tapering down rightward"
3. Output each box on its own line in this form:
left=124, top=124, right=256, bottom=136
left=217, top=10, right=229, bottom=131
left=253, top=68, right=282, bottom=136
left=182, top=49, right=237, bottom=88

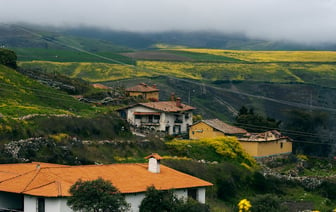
left=0, top=65, right=95, bottom=117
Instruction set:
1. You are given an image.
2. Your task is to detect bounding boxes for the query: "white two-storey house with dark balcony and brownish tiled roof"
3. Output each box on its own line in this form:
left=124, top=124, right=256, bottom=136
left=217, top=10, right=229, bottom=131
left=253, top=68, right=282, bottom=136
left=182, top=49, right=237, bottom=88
left=118, top=98, right=195, bottom=135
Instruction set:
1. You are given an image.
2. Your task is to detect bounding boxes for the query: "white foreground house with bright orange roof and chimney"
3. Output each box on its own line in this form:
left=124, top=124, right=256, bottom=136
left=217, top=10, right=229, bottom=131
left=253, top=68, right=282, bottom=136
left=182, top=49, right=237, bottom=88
left=0, top=154, right=212, bottom=212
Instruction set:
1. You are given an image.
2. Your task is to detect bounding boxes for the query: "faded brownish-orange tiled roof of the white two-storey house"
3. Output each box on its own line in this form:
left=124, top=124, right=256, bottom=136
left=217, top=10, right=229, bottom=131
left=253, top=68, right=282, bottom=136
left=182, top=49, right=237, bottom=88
left=139, top=101, right=196, bottom=112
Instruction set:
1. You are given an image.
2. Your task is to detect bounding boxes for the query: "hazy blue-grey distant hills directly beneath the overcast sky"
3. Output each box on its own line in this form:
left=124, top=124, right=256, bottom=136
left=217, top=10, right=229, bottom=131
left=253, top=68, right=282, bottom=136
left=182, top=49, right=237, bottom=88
left=0, top=24, right=336, bottom=50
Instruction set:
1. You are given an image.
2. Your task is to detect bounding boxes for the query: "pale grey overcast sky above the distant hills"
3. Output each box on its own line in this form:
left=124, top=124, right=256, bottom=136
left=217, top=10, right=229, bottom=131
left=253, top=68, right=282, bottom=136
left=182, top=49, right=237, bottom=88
left=0, top=0, right=336, bottom=43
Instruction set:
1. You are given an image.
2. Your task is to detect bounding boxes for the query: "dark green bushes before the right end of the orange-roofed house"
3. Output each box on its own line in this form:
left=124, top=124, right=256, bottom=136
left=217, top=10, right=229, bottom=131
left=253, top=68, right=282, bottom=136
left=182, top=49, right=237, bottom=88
left=139, top=186, right=210, bottom=212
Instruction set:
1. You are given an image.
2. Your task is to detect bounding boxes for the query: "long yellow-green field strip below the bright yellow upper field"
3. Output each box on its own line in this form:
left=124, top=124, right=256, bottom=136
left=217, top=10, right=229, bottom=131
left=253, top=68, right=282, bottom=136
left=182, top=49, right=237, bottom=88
left=19, top=53, right=336, bottom=88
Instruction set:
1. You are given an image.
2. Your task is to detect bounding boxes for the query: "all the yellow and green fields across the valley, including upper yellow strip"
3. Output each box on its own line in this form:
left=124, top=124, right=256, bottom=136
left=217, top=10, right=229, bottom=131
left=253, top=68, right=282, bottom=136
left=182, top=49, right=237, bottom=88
left=20, top=49, right=336, bottom=87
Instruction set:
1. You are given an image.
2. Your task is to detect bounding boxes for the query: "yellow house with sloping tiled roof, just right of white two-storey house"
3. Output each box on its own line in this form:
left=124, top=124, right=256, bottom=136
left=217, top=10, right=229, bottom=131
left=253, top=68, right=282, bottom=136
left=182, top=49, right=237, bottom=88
left=189, top=119, right=247, bottom=139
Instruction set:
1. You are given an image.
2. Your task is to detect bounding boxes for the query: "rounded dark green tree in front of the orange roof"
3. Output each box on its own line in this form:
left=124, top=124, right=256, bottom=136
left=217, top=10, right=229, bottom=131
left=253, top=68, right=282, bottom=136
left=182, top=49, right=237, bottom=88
left=67, top=178, right=129, bottom=212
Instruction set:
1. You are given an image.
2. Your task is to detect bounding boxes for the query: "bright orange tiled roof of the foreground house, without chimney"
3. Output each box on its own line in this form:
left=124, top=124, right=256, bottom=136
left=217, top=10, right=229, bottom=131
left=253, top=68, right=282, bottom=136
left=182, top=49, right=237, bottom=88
left=0, top=163, right=212, bottom=197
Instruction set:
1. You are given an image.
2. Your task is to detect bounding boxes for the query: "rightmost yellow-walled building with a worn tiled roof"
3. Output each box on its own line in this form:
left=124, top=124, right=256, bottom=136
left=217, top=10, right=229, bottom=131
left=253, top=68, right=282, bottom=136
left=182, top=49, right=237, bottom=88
left=238, top=130, right=292, bottom=158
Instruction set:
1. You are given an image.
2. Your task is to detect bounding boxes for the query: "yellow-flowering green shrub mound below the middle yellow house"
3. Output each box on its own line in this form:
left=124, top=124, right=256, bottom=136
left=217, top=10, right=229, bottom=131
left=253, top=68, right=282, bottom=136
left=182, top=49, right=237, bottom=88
left=167, top=136, right=256, bottom=167
